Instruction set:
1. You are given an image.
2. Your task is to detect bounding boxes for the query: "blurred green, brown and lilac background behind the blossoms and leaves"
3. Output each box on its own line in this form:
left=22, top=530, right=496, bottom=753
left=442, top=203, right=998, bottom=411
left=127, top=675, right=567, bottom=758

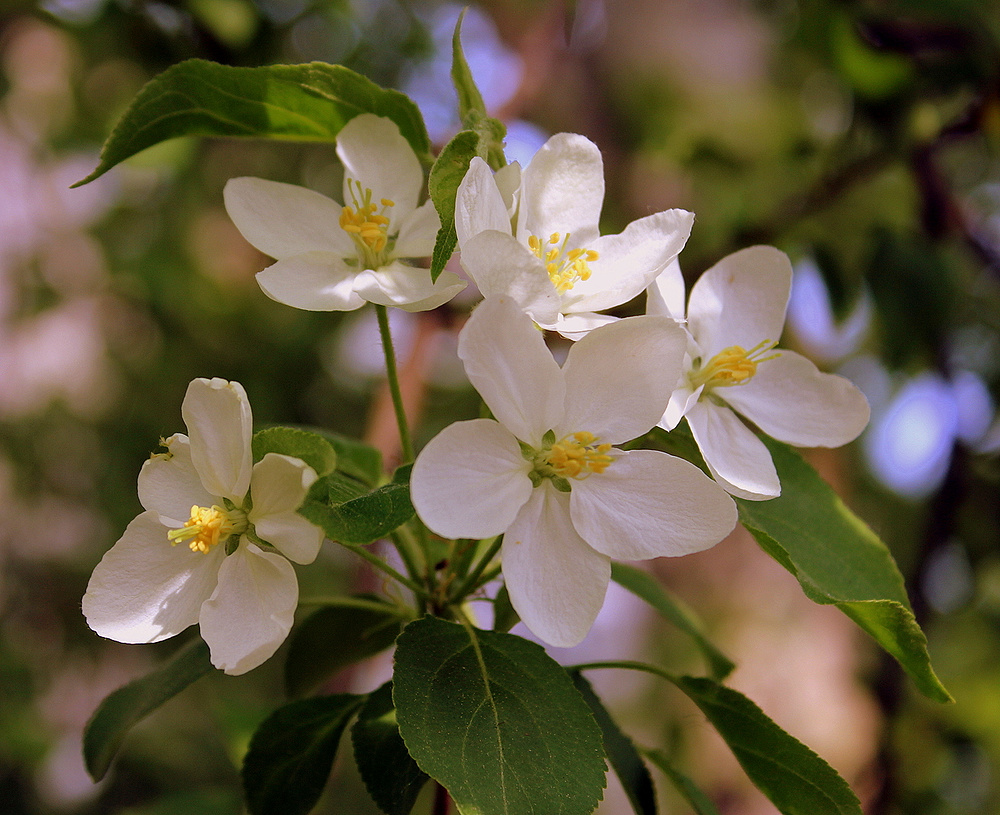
left=0, top=0, right=1000, bottom=815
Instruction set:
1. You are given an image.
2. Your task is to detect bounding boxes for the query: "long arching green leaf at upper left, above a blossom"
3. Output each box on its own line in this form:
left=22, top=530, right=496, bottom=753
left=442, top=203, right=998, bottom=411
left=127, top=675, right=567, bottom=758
left=74, top=59, right=430, bottom=186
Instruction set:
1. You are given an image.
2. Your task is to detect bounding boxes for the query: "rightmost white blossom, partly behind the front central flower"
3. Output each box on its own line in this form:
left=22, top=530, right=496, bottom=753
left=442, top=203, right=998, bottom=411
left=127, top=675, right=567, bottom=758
left=647, top=246, right=869, bottom=500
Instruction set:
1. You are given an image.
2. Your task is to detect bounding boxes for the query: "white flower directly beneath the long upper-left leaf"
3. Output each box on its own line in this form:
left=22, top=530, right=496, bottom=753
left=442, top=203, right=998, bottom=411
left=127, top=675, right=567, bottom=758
left=224, top=113, right=466, bottom=311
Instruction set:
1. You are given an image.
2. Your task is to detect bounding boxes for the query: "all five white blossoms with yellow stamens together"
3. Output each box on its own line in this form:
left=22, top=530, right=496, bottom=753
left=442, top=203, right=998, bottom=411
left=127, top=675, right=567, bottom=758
left=84, top=114, right=868, bottom=673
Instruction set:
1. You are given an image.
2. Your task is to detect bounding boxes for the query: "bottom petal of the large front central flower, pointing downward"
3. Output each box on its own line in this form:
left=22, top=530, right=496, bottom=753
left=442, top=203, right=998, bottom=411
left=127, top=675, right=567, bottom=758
left=501, top=484, right=611, bottom=648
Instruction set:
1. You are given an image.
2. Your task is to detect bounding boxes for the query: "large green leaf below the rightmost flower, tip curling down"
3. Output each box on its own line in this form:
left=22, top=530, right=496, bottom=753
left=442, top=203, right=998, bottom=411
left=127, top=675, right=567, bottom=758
left=736, top=437, right=951, bottom=702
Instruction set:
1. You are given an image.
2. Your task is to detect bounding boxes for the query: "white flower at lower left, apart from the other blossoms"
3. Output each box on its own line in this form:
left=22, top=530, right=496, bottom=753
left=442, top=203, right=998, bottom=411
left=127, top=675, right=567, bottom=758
left=83, top=379, right=323, bottom=674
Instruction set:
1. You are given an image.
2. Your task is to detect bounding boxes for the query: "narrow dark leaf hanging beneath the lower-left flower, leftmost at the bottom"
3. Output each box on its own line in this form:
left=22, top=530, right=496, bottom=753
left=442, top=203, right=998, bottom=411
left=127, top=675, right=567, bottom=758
left=83, top=637, right=212, bottom=781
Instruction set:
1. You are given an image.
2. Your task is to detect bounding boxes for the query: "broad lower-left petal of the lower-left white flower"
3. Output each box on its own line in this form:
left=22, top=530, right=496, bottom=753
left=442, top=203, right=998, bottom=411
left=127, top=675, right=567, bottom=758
left=83, top=512, right=224, bottom=643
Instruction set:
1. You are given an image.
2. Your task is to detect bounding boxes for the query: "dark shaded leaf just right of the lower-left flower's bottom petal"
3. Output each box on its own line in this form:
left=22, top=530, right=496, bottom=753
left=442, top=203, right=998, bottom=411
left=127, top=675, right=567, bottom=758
left=285, top=597, right=403, bottom=698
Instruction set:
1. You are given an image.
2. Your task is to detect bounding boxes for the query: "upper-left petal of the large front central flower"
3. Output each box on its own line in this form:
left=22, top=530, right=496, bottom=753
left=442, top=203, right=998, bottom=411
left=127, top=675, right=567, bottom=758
left=458, top=296, right=568, bottom=447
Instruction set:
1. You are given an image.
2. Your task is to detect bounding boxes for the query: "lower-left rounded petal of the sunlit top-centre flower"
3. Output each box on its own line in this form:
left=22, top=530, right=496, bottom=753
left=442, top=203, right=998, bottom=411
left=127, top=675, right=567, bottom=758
left=462, top=230, right=560, bottom=325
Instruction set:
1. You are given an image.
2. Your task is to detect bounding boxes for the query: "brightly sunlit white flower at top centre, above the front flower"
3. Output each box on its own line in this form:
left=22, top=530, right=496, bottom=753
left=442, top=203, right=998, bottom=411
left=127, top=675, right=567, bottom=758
left=455, top=133, right=694, bottom=339
